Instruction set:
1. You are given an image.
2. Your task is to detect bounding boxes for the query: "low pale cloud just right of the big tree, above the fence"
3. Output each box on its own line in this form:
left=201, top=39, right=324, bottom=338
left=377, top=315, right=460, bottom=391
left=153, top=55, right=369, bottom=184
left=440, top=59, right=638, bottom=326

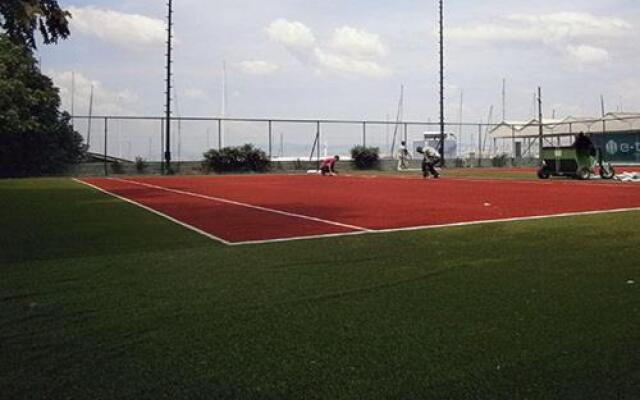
left=47, top=70, right=137, bottom=115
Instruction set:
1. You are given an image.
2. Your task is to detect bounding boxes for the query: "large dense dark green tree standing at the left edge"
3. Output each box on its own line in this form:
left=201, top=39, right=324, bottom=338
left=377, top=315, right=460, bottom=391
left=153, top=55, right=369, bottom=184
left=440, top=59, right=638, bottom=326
left=0, top=35, right=84, bottom=177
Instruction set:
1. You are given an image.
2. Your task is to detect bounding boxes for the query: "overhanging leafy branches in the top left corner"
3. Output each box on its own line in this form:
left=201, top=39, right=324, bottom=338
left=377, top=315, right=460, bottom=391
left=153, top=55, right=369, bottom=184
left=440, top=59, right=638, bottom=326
left=0, top=0, right=71, bottom=48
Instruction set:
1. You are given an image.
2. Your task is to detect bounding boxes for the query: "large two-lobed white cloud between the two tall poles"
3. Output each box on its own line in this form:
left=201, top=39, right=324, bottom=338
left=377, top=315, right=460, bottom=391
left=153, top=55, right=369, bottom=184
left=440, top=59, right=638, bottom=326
left=267, top=19, right=391, bottom=78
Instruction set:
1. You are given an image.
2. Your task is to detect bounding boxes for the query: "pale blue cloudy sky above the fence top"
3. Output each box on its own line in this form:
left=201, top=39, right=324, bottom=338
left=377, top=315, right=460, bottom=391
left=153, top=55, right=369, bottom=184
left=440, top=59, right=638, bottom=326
left=32, top=0, right=640, bottom=159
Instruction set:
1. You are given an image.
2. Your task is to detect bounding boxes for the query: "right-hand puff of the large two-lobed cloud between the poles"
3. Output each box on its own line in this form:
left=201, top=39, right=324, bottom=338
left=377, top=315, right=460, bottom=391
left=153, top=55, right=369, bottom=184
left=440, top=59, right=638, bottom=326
left=330, top=26, right=386, bottom=58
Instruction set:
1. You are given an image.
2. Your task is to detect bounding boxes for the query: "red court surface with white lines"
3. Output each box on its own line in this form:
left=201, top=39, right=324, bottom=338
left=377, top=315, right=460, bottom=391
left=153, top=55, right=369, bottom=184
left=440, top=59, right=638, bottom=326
left=81, top=175, right=640, bottom=244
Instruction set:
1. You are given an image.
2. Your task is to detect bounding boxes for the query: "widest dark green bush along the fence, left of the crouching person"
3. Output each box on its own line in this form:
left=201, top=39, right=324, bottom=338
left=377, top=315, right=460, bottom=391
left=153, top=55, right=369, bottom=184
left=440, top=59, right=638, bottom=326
left=203, top=144, right=270, bottom=172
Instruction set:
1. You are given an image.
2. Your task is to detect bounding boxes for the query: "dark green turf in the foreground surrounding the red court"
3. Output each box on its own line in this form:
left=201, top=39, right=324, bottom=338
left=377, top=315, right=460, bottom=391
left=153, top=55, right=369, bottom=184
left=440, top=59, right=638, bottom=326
left=0, top=179, right=640, bottom=399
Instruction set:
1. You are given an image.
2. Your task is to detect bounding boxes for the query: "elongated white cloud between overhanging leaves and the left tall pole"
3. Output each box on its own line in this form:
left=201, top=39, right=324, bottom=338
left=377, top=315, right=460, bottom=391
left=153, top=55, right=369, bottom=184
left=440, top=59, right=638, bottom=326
left=69, top=6, right=166, bottom=50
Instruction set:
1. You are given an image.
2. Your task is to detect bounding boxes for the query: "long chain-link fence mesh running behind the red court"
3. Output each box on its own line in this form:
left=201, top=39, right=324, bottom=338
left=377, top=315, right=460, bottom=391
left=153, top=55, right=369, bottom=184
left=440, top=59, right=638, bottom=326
left=72, top=116, right=640, bottom=166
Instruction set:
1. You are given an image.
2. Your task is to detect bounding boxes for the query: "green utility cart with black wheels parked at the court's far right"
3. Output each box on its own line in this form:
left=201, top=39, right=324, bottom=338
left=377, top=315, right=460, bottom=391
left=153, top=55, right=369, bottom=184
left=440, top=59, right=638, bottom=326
left=538, top=146, right=615, bottom=180
